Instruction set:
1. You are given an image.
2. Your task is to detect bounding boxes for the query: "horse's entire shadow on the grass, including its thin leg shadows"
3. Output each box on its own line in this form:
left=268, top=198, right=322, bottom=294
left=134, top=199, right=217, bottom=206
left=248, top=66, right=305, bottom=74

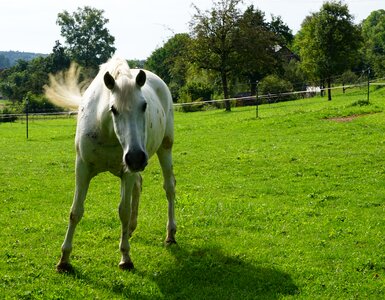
left=59, top=245, right=299, bottom=300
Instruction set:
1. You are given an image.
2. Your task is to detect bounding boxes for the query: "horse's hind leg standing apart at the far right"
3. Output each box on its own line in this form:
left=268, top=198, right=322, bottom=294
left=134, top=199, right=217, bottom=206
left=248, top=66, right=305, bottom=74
left=157, top=142, right=176, bottom=244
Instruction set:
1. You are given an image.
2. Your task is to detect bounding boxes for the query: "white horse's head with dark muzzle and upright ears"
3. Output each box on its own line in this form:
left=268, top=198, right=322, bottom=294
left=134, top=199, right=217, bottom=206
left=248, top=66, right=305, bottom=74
left=104, top=70, right=148, bottom=172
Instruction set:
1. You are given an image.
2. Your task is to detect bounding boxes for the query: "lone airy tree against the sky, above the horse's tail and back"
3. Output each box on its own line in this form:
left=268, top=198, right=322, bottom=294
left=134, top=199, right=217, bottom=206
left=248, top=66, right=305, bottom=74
left=56, top=6, right=116, bottom=67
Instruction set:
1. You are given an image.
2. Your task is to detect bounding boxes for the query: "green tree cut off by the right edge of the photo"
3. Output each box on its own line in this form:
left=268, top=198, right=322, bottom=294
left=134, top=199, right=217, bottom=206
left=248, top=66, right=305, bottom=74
left=362, top=9, right=385, bottom=76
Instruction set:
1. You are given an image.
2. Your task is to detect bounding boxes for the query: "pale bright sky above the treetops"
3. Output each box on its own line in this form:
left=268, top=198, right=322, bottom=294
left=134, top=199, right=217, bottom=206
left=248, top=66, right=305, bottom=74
left=0, top=0, right=385, bottom=59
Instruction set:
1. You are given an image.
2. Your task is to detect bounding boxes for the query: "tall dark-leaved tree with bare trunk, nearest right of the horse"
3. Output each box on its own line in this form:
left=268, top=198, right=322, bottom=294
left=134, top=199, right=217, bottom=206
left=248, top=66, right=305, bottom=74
left=190, top=0, right=241, bottom=111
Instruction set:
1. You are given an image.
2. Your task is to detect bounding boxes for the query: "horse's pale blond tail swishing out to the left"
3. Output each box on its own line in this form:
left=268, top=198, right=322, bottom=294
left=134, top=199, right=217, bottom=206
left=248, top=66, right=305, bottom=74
left=44, top=63, right=84, bottom=109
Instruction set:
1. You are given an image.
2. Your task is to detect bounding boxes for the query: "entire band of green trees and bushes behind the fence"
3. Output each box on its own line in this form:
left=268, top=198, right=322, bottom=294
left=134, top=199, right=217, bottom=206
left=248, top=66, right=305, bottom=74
left=0, top=0, right=385, bottom=110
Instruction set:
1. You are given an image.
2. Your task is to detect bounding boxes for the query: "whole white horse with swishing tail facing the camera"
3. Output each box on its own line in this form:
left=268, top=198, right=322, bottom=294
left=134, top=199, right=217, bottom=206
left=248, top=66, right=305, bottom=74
left=45, top=57, right=176, bottom=271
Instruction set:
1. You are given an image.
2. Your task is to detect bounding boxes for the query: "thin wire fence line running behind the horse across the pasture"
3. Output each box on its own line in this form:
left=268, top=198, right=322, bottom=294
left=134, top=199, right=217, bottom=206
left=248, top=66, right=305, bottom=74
left=0, top=78, right=385, bottom=123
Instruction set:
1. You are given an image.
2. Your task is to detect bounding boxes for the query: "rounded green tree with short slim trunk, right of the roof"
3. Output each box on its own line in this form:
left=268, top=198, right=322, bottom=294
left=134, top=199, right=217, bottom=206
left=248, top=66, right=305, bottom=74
left=295, top=1, right=361, bottom=100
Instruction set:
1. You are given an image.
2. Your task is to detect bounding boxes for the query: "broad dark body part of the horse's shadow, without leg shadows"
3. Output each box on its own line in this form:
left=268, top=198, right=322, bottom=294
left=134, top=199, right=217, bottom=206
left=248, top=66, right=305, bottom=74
left=152, top=245, right=298, bottom=299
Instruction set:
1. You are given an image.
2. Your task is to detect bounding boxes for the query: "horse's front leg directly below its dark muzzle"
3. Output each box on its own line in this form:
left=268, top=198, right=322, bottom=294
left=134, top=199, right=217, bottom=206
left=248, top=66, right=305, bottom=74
left=119, top=173, right=138, bottom=270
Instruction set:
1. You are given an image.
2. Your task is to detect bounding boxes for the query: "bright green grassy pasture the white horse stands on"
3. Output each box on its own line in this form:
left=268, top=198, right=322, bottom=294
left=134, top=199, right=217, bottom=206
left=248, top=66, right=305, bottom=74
left=0, top=89, right=385, bottom=299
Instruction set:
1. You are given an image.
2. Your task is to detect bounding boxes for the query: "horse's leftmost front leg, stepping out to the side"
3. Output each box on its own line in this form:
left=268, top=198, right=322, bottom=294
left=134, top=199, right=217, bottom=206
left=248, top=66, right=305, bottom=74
left=56, top=157, right=92, bottom=272
